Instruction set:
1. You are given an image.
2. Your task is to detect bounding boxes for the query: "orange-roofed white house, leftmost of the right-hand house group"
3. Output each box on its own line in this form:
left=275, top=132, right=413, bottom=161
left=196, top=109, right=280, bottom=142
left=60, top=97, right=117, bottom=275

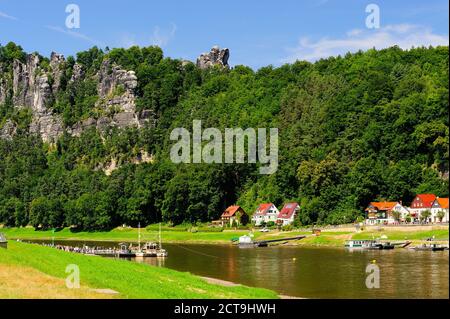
left=365, top=202, right=409, bottom=225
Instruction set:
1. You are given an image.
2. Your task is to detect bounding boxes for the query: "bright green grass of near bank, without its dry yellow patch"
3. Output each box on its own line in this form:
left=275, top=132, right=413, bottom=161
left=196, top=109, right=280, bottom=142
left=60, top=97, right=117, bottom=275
left=0, top=242, right=278, bottom=299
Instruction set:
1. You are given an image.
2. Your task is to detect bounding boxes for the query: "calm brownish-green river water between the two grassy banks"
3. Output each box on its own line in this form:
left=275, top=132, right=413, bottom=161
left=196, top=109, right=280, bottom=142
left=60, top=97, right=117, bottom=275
left=31, top=241, right=449, bottom=298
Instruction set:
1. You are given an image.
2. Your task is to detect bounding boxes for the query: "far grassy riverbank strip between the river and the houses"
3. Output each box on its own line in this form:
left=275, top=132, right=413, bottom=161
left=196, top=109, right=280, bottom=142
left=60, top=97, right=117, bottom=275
left=0, top=225, right=449, bottom=247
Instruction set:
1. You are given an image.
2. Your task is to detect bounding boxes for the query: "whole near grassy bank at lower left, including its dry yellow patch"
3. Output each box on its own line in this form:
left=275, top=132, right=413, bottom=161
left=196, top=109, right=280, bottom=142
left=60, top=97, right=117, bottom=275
left=0, top=242, right=278, bottom=299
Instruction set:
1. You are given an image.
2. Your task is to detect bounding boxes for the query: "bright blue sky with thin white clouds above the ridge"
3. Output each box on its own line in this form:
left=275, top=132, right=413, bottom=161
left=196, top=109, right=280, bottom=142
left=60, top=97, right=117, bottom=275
left=0, top=0, right=449, bottom=68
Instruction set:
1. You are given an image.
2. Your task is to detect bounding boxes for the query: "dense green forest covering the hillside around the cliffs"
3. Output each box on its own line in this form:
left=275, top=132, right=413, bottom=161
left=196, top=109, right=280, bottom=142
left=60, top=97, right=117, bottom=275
left=0, top=43, right=449, bottom=230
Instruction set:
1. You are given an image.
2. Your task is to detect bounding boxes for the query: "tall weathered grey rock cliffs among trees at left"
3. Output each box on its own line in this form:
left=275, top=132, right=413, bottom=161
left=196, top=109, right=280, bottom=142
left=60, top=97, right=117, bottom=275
left=0, top=52, right=154, bottom=142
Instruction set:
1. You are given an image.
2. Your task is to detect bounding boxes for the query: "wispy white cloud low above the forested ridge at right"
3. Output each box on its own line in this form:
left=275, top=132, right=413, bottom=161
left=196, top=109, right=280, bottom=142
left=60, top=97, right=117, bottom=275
left=281, top=24, right=449, bottom=63
